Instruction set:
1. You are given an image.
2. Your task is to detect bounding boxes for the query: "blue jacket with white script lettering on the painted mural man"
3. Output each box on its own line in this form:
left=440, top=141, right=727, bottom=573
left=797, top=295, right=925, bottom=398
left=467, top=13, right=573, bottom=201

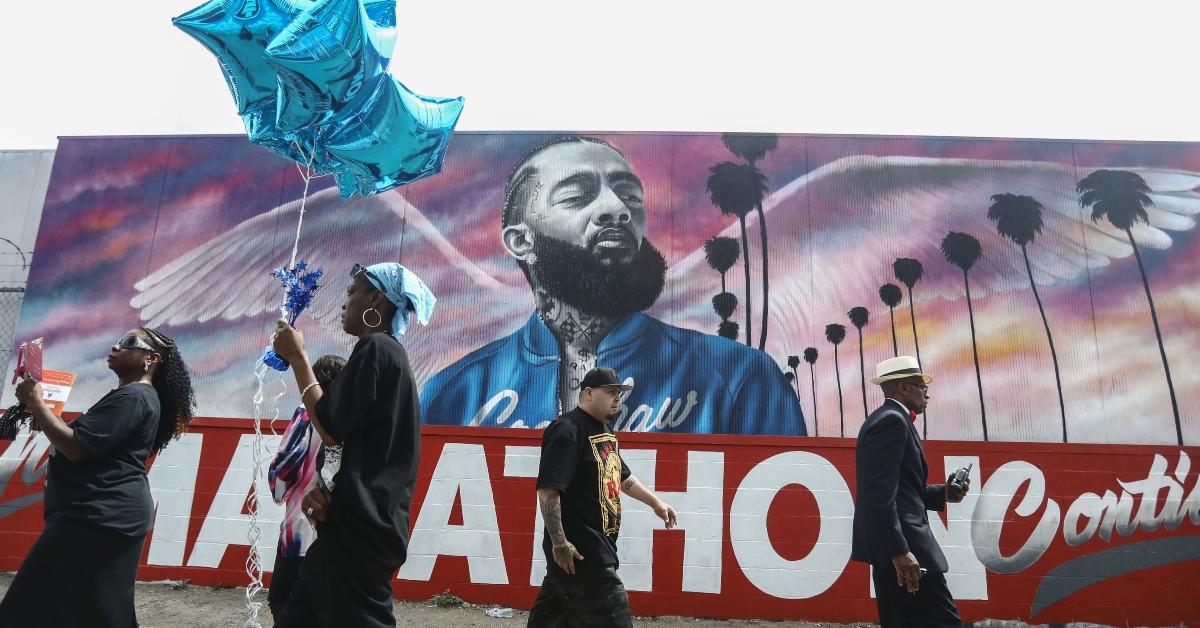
left=421, top=313, right=806, bottom=436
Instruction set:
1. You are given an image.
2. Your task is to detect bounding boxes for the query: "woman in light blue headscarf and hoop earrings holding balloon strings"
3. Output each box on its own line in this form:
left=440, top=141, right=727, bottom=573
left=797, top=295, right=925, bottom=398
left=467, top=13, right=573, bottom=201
left=274, top=263, right=436, bottom=627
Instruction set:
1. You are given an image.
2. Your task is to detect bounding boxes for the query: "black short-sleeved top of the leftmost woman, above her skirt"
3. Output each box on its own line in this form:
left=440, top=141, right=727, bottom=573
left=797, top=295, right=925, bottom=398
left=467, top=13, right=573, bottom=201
left=44, top=383, right=161, bottom=536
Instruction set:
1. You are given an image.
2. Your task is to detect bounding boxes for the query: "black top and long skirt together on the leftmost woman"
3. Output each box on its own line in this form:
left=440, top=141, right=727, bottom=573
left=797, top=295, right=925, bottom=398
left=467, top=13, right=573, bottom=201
left=0, top=383, right=160, bottom=628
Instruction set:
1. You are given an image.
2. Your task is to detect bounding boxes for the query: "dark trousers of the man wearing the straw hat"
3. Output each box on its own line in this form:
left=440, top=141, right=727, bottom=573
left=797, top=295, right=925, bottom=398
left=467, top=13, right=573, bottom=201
left=871, top=566, right=962, bottom=628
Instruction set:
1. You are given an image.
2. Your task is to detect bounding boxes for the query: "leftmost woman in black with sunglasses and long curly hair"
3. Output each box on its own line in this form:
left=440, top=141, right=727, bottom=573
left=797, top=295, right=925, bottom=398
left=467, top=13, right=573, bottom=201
left=0, top=328, right=196, bottom=628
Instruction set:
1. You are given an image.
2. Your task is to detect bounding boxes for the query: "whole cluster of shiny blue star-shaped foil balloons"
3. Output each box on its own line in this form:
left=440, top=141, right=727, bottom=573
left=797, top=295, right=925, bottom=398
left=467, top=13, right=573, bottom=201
left=173, top=0, right=462, bottom=197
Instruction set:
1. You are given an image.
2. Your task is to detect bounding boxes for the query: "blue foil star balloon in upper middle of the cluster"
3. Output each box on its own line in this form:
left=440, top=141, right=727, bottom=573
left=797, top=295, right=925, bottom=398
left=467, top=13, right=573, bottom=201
left=266, top=0, right=384, bottom=132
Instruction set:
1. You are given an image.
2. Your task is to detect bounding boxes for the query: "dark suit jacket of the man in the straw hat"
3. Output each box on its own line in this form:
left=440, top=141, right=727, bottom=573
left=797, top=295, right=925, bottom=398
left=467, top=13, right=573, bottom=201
left=850, top=400, right=947, bottom=573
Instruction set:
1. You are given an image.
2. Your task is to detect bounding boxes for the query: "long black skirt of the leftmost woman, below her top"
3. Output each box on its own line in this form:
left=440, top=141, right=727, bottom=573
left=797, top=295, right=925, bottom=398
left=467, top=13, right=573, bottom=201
left=0, top=521, right=145, bottom=628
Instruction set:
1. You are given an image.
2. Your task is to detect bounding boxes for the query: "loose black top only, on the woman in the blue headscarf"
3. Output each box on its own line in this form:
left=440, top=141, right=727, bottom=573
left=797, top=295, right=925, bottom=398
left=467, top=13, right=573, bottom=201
left=317, top=334, right=421, bottom=569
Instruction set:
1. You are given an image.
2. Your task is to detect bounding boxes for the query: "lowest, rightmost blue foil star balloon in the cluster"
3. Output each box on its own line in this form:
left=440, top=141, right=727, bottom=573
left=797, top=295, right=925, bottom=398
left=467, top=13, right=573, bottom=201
left=324, top=77, right=463, bottom=197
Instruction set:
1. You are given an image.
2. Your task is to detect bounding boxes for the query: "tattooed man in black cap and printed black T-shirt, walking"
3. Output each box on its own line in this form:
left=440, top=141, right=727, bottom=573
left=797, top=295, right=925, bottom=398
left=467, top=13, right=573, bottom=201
left=528, top=367, right=678, bottom=628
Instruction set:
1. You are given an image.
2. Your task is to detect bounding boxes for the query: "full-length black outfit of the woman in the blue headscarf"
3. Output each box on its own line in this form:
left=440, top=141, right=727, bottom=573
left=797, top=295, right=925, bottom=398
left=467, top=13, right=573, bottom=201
left=276, top=334, right=421, bottom=627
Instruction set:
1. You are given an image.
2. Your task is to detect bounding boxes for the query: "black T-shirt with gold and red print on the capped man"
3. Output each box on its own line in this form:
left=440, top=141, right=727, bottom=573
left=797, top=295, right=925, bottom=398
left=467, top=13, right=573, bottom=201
left=538, top=408, right=630, bottom=568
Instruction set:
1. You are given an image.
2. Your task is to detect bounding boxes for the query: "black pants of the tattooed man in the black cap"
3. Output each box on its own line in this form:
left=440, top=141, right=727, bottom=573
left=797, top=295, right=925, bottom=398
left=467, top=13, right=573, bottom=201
left=527, top=561, right=634, bottom=628
